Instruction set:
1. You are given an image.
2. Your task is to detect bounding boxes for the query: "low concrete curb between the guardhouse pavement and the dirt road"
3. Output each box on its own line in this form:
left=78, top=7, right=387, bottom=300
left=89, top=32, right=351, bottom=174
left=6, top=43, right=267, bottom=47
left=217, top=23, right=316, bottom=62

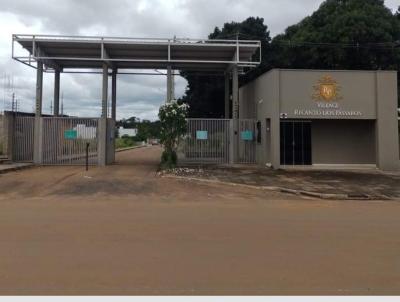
left=161, top=174, right=393, bottom=200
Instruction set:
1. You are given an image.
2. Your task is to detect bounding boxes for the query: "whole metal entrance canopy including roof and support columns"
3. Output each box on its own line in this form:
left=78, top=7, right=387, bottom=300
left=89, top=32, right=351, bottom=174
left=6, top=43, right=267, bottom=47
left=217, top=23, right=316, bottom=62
left=12, top=34, right=261, bottom=165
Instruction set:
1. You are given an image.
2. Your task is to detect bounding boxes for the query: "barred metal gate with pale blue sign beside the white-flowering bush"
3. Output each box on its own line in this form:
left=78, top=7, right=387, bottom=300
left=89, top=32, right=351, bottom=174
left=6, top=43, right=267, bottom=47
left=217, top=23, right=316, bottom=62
left=178, top=119, right=232, bottom=164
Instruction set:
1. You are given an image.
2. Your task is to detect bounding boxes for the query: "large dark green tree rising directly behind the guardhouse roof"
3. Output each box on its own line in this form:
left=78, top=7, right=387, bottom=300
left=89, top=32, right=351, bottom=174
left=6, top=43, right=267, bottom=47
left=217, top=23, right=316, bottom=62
left=271, top=0, right=400, bottom=70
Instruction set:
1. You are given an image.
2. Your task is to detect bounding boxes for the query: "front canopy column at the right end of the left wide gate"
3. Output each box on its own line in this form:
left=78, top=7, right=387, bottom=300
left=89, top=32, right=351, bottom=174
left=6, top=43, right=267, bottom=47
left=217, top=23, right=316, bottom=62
left=98, top=63, right=108, bottom=166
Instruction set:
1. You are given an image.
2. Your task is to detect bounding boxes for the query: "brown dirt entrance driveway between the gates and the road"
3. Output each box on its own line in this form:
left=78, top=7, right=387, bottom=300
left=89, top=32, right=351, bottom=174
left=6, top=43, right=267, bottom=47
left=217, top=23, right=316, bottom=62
left=0, top=146, right=295, bottom=202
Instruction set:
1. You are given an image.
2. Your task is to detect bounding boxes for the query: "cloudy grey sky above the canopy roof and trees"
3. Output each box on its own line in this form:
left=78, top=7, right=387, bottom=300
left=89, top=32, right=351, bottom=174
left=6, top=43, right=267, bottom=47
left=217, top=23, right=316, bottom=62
left=0, top=0, right=399, bottom=37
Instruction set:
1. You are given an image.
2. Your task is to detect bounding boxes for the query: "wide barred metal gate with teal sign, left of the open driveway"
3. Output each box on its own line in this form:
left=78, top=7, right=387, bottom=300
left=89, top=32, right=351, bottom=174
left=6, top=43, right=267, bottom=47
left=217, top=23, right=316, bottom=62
left=42, top=117, right=98, bottom=165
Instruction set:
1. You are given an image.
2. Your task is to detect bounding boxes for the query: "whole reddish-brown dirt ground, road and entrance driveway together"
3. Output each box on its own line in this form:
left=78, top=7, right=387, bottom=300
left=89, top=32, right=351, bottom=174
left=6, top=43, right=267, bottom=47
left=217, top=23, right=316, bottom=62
left=0, top=147, right=400, bottom=295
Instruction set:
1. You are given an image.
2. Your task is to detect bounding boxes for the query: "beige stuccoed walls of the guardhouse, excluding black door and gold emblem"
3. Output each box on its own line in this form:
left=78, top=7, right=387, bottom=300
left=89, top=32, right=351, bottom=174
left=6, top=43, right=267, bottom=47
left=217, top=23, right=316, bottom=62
left=240, top=69, right=400, bottom=170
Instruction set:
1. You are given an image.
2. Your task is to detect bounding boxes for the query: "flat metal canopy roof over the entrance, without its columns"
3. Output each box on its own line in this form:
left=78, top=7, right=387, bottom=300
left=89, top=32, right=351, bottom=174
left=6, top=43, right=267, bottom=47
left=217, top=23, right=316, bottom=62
left=12, top=34, right=261, bottom=72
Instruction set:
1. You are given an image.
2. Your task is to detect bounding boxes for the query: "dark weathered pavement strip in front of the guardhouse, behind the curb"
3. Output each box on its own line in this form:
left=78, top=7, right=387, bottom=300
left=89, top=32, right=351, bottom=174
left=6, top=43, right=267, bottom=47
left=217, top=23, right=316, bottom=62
left=165, top=166, right=400, bottom=200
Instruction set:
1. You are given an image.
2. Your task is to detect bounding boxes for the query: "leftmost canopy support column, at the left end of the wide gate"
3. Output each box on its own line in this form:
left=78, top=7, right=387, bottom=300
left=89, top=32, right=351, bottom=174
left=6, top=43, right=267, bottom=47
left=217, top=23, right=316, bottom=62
left=33, top=61, right=43, bottom=165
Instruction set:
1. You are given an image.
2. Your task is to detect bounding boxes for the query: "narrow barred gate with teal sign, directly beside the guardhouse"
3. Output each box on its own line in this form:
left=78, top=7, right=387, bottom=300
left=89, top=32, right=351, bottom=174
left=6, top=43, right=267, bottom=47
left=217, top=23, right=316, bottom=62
left=238, top=119, right=256, bottom=164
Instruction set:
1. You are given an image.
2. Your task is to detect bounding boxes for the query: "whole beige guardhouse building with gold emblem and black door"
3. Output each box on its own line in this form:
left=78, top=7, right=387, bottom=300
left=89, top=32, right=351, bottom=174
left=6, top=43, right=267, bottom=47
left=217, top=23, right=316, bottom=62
left=239, top=69, right=399, bottom=170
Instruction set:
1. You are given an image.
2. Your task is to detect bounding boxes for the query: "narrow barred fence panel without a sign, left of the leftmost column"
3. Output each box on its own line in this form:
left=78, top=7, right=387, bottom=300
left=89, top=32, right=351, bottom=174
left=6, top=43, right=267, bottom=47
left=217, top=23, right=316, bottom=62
left=9, top=116, right=35, bottom=162
